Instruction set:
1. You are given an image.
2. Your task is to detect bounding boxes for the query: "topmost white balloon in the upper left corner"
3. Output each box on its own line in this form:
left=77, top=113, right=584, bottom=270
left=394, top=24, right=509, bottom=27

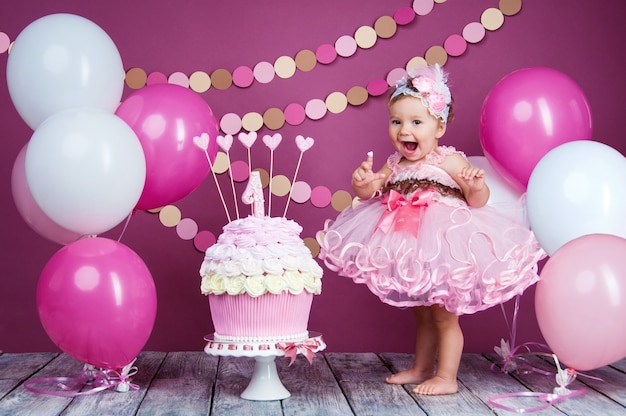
left=7, top=13, right=125, bottom=129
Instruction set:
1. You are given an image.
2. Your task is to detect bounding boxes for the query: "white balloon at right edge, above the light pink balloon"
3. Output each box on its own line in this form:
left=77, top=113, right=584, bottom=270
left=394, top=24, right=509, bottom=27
left=526, top=140, right=626, bottom=255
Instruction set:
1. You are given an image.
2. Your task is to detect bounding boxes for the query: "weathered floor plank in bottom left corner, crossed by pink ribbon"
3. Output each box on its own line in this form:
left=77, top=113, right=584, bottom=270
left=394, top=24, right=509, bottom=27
left=0, top=354, right=83, bottom=416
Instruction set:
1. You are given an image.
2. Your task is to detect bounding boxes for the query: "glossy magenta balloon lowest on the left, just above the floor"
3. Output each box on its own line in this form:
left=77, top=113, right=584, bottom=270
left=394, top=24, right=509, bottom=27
left=37, top=237, right=156, bottom=369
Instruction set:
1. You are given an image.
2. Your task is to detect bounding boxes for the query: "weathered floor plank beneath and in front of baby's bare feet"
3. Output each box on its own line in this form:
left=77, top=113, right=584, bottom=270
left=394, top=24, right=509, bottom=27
left=381, top=353, right=493, bottom=416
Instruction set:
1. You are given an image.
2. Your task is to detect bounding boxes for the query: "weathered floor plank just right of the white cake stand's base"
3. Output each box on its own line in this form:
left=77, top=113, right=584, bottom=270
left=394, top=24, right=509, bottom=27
left=276, top=354, right=352, bottom=416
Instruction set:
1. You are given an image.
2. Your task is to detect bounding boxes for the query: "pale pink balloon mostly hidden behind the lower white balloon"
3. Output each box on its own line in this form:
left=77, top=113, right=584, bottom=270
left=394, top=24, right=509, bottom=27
left=11, top=144, right=81, bottom=244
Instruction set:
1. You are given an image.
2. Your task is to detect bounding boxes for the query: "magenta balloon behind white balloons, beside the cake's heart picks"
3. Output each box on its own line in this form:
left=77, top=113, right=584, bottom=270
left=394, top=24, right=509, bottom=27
left=116, top=84, right=218, bottom=210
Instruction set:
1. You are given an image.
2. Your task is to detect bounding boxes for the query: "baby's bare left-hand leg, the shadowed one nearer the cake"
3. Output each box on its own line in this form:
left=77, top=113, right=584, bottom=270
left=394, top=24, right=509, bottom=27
left=385, top=306, right=437, bottom=384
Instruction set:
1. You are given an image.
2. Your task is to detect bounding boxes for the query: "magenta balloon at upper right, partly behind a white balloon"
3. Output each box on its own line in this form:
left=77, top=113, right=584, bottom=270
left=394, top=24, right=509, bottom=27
left=479, top=67, right=592, bottom=192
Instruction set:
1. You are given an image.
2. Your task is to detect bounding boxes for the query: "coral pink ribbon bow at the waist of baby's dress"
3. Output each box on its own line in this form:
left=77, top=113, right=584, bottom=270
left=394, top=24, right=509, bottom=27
left=376, top=189, right=437, bottom=237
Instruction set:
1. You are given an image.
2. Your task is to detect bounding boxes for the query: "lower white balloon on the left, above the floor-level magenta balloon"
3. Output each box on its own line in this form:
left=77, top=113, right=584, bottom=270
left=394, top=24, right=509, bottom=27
left=25, top=108, right=146, bottom=234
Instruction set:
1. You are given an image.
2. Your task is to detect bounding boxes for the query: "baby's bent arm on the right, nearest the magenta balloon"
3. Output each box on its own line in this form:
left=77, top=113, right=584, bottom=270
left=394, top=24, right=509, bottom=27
left=440, top=154, right=489, bottom=208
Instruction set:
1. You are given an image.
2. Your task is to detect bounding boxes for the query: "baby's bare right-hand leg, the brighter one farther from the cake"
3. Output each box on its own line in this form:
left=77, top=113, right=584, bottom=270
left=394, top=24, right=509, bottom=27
left=413, top=306, right=463, bottom=395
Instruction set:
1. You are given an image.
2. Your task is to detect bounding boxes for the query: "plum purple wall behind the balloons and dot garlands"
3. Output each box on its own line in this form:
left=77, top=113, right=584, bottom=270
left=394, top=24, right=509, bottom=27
left=0, top=0, right=626, bottom=352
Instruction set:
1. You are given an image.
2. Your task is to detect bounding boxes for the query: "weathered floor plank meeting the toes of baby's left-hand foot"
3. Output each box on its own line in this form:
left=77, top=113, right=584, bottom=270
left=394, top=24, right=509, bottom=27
left=326, top=353, right=426, bottom=415
